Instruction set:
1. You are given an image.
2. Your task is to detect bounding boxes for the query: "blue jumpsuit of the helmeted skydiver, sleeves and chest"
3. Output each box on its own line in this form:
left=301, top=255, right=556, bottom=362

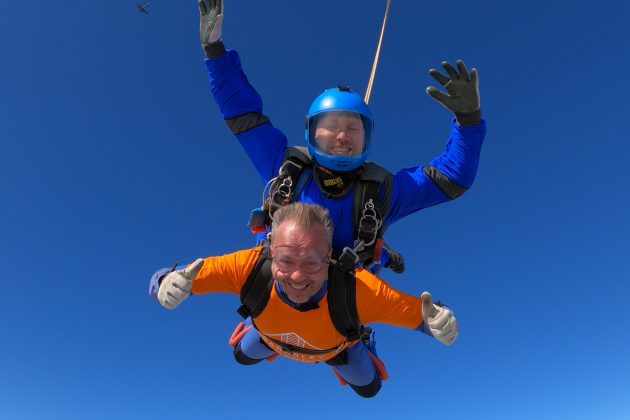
left=205, top=50, right=486, bottom=253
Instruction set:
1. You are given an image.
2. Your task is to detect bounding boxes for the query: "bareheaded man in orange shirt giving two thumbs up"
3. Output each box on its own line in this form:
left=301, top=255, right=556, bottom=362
left=150, top=203, right=458, bottom=397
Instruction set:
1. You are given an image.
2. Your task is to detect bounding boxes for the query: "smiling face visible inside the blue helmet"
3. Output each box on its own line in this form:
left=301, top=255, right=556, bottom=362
left=315, top=111, right=365, bottom=156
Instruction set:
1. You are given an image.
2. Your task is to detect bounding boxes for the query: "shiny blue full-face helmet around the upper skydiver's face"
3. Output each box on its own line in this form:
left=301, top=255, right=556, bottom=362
left=305, top=86, right=374, bottom=171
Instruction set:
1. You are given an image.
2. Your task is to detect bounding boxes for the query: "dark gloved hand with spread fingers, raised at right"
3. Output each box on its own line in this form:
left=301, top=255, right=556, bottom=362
left=427, top=60, right=480, bottom=114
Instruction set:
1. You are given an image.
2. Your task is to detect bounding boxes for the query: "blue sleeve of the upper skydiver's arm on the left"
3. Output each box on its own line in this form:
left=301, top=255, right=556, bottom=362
left=205, top=50, right=287, bottom=184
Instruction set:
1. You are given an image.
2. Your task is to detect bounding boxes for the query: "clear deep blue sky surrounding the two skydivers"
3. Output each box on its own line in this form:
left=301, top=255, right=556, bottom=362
left=0, top=0, right=630, bottom=419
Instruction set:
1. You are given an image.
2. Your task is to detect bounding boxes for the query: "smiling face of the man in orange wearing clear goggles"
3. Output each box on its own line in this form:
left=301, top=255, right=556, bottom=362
left=271, top=220, right=332, bottom=303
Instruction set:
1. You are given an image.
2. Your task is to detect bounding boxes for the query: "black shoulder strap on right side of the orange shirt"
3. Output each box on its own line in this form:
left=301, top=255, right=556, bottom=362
left=327, top=254, right=363, bottom=341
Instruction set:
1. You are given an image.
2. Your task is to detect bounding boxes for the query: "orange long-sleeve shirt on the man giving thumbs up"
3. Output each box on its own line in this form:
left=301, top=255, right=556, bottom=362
left=192, top=247, right=422, bottom=363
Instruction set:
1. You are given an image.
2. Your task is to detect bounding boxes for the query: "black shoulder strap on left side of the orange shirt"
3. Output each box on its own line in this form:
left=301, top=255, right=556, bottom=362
left=236, top=248, right=273, bottom=318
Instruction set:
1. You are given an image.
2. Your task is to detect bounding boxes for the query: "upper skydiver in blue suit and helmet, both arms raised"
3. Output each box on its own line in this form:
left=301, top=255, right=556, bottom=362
left=198, top=0, right=486, bottom=272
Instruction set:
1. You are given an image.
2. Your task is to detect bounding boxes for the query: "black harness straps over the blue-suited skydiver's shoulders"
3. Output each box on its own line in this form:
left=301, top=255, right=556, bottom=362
left=248, top=146, right=405, bottom=274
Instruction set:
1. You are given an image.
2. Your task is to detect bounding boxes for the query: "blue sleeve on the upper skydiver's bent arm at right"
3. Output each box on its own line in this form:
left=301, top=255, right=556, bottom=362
left=385, top=120, right=486, bottom=224
